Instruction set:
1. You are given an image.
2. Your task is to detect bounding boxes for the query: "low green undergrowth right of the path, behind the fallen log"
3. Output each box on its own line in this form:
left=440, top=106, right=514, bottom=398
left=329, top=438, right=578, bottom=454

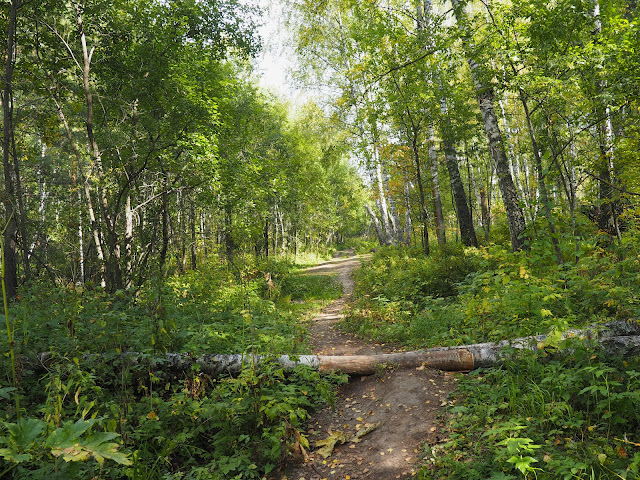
left=345, top=232, right=640, bottom=346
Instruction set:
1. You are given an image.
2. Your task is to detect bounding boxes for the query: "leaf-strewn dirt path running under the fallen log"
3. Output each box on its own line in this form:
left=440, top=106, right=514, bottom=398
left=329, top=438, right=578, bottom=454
left=278, top=251, right=456, bottom=480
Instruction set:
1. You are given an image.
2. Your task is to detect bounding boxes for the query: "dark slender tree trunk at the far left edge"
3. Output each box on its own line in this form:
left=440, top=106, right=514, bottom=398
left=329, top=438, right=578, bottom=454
left=2, top=0, right=21, bottom=299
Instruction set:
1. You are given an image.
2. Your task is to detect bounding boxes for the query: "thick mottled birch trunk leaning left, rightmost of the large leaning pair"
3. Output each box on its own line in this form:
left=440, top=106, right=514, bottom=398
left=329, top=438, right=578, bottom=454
left=451, top=0, right=526, bottom=250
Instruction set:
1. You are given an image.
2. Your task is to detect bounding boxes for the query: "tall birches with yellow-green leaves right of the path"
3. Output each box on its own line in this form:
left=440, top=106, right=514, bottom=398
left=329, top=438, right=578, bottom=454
left=293, top=0, right=640, bottom=255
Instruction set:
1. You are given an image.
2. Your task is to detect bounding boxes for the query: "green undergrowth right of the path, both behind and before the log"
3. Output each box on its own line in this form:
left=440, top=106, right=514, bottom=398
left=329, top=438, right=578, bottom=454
left=344, top=232, right=640, bottom=480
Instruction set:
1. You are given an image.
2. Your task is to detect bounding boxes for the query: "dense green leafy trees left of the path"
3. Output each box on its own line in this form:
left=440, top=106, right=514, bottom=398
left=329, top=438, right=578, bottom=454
left=1, top=0, right=362, bottom=297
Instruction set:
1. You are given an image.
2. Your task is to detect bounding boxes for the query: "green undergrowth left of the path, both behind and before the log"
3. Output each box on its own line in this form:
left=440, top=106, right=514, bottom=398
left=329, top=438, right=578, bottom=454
left=0, top=255, right=342, bottom=479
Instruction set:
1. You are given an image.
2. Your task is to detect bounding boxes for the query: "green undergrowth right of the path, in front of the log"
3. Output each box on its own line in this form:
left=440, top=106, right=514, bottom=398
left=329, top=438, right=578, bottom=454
left=419, top=344, right=640, bottom=480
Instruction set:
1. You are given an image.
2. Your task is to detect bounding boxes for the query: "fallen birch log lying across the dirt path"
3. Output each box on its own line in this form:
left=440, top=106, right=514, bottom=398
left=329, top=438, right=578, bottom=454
left=24, top=320, right=640, bottom=377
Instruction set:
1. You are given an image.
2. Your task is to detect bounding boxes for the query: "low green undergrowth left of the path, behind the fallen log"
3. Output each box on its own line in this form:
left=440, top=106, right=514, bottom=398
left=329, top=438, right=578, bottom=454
left=5, top=256, right=341, bottom=357
